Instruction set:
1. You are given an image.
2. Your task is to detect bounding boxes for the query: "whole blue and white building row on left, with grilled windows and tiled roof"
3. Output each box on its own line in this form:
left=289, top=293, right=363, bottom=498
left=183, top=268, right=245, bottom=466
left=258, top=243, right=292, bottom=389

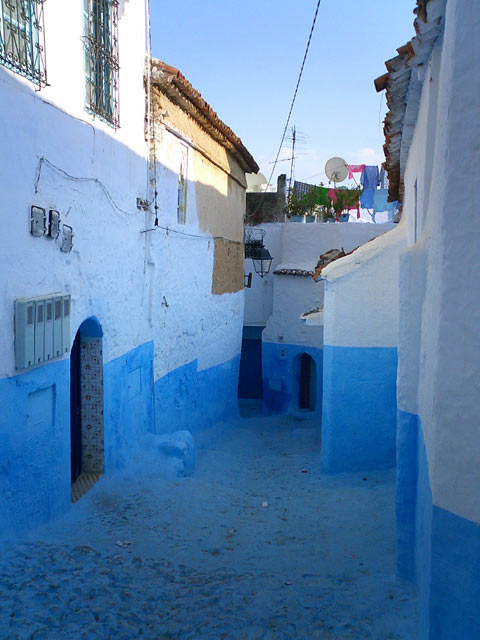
left=0, top=0, right=258, bottom=535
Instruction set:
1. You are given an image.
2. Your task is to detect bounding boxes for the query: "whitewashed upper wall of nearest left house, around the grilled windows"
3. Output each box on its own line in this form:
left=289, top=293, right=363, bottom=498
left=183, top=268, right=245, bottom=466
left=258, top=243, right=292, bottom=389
left=0, top=0, right=149, bottom=376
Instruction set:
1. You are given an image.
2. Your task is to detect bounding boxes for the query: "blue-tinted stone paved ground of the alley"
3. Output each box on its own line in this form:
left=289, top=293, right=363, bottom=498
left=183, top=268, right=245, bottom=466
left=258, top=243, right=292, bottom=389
left=0, top=417, right=416, bottom=640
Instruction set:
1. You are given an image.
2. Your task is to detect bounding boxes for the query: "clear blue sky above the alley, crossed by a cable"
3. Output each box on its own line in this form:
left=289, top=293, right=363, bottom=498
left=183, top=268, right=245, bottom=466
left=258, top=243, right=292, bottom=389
left=151, top=0, right=416, bottom=188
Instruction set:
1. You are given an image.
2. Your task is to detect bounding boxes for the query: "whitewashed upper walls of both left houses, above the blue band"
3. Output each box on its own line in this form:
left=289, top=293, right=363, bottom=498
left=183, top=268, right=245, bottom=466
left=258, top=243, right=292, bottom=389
left=0, top=0, right=243, bottom=378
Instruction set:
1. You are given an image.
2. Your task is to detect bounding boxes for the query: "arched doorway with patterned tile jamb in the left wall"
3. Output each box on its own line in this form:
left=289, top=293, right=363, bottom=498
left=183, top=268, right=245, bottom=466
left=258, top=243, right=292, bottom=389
left=70, top=318, right=105, bottom=502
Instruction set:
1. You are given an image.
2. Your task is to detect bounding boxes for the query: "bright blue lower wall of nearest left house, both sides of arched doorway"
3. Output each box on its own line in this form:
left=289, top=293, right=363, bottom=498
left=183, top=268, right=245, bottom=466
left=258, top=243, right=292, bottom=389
left=0, top=342, right=154, bottom=536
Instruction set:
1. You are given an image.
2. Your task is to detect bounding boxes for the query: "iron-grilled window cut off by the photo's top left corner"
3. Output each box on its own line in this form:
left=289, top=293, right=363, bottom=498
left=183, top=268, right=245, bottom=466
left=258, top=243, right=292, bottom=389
left=0, top=0, right=47, bottom=87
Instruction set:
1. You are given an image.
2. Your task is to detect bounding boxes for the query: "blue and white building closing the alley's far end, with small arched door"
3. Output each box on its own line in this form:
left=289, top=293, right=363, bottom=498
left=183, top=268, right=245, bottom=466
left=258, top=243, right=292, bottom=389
left=240, top=222, right=395, bottom=418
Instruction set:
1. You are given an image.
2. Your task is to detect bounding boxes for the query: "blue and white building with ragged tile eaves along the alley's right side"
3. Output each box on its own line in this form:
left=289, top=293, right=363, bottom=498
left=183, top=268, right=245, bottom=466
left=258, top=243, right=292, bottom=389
left=322, top=0, right=480, bottom=640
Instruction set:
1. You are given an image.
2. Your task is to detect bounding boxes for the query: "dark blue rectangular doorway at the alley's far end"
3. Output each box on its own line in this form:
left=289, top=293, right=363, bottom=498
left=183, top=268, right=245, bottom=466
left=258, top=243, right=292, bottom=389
left=238, top=326, right=265, bottom=399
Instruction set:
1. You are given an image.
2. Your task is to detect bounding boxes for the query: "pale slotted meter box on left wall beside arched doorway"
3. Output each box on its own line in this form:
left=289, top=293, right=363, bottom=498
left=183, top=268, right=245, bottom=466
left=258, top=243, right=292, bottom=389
left=15, top=293, right=71, bottom=370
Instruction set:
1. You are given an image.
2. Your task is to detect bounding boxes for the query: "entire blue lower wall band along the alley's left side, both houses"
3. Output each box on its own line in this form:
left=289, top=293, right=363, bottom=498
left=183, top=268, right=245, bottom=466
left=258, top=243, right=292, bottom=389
left=0, top=342, right=240, bottom=537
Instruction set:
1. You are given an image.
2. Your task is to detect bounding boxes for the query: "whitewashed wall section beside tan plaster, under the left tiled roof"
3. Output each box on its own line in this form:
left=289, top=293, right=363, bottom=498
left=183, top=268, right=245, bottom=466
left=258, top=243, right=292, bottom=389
left=146, top=125, right=244, bottom=378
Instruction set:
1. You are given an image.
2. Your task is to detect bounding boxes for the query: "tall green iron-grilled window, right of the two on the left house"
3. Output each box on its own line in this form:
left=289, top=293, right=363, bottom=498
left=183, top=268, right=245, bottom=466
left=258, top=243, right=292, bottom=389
left=84, top=0, right=119, bottom=128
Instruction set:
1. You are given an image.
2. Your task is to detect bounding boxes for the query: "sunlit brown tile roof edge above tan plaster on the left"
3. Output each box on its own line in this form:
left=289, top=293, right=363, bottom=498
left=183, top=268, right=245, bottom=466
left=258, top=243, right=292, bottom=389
left=151, top=58, right=259, bottom=173
